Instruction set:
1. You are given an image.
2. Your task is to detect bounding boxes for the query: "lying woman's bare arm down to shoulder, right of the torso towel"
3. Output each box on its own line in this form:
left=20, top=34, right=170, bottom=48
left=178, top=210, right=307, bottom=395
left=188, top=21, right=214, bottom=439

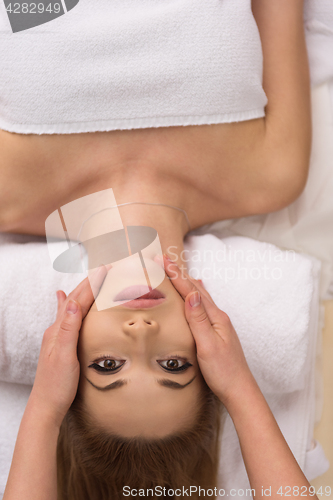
left=252, top=0, right=312, bottom=209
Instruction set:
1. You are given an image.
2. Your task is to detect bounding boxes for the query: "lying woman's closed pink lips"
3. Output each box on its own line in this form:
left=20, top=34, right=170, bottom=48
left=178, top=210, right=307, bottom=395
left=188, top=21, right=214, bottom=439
left=113, top=285, right=165, bottom=309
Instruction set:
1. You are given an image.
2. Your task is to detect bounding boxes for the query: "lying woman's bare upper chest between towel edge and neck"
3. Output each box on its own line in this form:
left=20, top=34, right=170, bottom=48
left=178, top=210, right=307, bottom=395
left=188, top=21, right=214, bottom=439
left=0, top=119, right=264, bottom=234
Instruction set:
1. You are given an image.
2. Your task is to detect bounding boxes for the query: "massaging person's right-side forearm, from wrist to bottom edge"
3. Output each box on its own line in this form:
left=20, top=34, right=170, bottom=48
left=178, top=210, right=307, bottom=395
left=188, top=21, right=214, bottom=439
left=222, top=378, right=317, bottom=500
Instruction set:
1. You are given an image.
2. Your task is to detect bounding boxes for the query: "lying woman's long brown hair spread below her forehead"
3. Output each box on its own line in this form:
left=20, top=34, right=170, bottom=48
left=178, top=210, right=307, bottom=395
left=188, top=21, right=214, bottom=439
left=57, top=385, right=220, bottom=500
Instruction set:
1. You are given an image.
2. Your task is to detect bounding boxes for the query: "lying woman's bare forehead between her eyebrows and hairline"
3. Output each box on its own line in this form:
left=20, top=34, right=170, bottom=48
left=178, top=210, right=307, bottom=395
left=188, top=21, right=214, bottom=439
left=84, top=376, right=202, bottom=437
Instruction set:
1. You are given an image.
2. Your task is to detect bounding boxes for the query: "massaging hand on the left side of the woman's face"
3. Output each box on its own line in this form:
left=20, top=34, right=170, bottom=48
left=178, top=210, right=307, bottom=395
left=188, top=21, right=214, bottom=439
left=28, top=266, right=110, bottom=426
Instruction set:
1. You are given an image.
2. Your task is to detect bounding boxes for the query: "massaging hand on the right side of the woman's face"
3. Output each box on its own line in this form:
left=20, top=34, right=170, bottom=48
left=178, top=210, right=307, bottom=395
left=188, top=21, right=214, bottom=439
left=164, top=256, right=256, bottom=409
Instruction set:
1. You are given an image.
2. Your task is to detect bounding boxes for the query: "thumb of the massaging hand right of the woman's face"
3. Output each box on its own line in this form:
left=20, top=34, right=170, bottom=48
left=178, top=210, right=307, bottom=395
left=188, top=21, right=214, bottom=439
left=185, top=291, right=213, bottom=342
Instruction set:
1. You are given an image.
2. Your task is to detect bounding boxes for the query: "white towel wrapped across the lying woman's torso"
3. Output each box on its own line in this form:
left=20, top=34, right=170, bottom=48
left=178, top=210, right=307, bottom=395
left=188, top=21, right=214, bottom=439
left=0, top=0, right=267, bottom=134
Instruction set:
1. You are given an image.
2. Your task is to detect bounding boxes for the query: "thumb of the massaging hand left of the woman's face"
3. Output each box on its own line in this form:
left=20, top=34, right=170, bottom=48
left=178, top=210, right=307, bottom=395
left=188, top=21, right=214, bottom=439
left=58, top=300, right=82, bottom=352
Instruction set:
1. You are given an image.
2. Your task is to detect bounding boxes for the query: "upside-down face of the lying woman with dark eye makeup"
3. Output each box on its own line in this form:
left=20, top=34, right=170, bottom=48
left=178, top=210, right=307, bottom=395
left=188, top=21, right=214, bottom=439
left=79, top=264, right=204, bottom=437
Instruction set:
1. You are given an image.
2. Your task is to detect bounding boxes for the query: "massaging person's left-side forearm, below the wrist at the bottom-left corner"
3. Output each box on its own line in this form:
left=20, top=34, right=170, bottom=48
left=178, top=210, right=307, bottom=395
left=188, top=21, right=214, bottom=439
left=3, top=401, right=59, bottom=500
